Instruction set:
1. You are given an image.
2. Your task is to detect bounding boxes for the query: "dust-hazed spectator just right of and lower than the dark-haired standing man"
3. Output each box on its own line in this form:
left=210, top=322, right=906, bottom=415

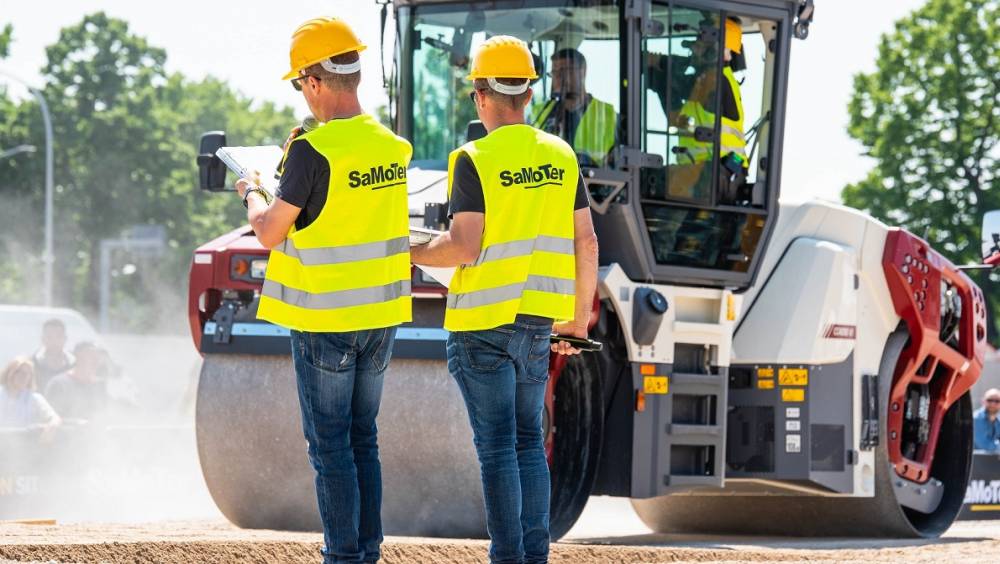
left=45, top=341, right=108, bottom=419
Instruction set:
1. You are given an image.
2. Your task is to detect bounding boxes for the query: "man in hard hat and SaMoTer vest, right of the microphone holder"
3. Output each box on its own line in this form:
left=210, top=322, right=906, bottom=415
left=411, top=36, right=597, bottom=562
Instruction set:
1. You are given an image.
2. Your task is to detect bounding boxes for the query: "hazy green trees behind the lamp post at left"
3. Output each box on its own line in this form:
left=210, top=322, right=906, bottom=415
left=0, top=13, right=294, bottom=329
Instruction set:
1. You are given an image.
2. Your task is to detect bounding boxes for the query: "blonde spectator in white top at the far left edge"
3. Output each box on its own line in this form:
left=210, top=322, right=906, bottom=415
left=0, top=356, right=61, bottom=431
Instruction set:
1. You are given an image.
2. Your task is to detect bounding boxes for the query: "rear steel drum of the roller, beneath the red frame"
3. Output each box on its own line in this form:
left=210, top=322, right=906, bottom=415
left=632, top=331, right=972, bottom=538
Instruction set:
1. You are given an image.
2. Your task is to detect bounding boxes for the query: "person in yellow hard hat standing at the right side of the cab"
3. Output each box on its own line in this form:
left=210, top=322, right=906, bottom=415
left=647, top=17, right=750, bottom=199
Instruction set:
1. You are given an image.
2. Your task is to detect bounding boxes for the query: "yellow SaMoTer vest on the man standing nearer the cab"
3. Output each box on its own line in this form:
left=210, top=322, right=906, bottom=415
left=444, top=125, right=580, bottom=331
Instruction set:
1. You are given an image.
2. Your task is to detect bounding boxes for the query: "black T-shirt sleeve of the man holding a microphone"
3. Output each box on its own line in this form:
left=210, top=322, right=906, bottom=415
left=274, top=141, right=330, bottom=230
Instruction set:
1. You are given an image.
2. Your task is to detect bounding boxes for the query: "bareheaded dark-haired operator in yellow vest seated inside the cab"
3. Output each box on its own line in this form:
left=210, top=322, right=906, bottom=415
left=532, top=48, right=618, bottom=167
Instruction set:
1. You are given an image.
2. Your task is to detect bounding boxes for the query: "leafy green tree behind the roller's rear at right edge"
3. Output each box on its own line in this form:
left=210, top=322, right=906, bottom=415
left=843, top=0, right=1000, bottom=335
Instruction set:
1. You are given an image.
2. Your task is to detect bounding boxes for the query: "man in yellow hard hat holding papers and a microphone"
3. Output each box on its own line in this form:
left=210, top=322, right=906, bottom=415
left=237, top=18, right=413, bottom=562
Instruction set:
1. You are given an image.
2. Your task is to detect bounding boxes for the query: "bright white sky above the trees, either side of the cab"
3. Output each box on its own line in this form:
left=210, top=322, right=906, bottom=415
left=0, top=0, right=923, bottom=201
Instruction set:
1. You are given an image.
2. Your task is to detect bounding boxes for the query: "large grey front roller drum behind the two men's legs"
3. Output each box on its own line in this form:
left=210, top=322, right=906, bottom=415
left=196, top=355, right=486, bottom=537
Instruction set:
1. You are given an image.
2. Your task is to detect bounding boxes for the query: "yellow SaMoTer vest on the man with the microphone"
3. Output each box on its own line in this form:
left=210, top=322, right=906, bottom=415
left=257, top=114, right=413, bottom=333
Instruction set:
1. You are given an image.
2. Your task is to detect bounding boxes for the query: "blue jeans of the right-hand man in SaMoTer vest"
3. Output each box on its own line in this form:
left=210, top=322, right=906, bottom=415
left=448, top=317, right=552, bottom=563
